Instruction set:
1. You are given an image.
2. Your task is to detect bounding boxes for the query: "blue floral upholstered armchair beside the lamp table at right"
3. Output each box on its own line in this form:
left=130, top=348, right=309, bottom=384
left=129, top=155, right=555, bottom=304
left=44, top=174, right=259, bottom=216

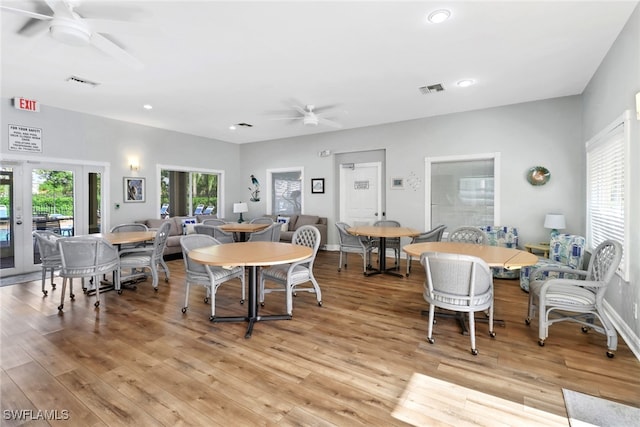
left=520, top=234, right=585, bottom=292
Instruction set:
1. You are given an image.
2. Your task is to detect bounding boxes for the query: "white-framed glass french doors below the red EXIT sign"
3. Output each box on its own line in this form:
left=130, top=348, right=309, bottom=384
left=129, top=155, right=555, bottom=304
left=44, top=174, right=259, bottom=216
left=0, top=161, right=104, bottom=276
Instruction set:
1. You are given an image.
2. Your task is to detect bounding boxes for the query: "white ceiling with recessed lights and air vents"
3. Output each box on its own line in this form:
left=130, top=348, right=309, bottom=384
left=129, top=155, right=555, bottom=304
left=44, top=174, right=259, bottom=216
left=0, top=0, right=638, bottom=143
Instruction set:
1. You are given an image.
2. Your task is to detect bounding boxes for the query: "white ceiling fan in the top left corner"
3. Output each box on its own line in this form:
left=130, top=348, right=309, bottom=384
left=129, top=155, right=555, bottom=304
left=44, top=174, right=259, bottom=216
left=0, top=0, right=144, bottom=69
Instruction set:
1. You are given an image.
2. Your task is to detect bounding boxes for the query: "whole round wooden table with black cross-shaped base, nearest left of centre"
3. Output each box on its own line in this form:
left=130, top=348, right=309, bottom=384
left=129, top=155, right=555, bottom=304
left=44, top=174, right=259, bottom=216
left=189, top=241, right=313, bottom=338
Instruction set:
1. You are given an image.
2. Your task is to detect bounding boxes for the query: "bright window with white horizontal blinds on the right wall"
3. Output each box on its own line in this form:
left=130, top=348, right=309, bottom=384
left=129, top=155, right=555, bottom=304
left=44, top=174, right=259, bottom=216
left=585, top=110, right=631, bottom=281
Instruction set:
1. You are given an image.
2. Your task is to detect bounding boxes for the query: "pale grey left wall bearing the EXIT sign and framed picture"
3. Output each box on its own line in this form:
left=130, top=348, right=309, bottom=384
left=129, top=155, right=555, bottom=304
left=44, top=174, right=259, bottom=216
left=0, top=99, right=240, bottom=228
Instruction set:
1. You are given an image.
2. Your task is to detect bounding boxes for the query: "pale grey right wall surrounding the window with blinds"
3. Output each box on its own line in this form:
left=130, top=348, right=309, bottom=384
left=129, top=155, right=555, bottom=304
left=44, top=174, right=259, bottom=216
left=582, top=6, right=640, bottom=358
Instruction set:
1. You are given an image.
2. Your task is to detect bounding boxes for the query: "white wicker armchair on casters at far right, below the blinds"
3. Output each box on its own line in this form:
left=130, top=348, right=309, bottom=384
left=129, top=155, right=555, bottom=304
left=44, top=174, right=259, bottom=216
left=525, top=240, right=622, bottom=358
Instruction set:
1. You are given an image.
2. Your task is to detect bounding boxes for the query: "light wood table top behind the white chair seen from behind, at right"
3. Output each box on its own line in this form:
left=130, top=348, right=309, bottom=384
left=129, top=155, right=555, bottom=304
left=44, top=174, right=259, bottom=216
left=402, top=242, right=538, bottom=270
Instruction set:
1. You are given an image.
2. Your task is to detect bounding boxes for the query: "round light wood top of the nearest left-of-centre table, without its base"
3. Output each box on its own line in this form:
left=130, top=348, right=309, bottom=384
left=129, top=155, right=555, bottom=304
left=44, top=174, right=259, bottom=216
left=189, top=242, right=313, bottom=267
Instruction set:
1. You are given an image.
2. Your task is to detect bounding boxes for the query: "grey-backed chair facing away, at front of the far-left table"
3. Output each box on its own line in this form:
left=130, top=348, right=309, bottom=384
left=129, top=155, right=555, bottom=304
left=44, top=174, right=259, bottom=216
left=58, top=235, right=120, bottom=311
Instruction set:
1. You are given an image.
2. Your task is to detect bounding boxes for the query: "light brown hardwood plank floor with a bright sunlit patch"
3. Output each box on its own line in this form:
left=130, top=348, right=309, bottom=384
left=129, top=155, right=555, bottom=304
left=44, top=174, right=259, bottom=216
left=0, top=251, right=640, bottom=426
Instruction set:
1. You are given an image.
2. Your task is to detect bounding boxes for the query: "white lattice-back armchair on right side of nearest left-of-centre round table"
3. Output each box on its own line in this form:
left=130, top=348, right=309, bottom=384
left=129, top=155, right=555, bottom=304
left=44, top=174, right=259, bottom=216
left=260, top=225, right=322, bottom=316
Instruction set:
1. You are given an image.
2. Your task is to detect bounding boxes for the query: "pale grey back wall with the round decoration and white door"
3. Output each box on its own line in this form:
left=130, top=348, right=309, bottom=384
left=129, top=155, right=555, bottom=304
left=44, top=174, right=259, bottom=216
left=240, top=96, right=584, bottom=249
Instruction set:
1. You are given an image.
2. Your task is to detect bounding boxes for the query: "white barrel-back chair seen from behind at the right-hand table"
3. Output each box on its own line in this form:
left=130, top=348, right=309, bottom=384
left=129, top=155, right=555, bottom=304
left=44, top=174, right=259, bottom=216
left=420, top=252, right=496, bottom=356
